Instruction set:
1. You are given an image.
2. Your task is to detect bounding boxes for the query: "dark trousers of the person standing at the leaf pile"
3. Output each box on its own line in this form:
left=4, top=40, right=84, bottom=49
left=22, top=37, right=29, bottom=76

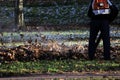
left=88, top=20, right=110, bottom=60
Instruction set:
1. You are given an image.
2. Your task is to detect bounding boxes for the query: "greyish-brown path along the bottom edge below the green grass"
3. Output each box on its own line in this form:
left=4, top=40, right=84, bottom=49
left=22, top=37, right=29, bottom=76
left=0, top=73, right=120, bottom=80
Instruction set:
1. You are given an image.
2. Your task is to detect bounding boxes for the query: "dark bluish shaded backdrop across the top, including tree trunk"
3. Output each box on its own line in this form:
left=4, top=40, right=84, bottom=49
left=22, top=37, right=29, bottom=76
left=0, top=0, right=120, bottom=30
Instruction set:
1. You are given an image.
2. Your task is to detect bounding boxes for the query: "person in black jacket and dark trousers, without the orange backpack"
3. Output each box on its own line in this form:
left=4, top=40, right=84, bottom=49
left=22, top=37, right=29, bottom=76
left=88, top=0, right=118, bottom=60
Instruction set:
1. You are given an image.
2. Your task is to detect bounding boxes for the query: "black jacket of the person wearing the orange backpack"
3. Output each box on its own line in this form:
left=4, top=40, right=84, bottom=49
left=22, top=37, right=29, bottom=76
left=88, top=0, right=118, bottom=23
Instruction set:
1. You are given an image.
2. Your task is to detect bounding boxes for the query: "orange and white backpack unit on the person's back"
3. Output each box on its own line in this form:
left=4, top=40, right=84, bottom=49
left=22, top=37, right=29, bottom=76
left=92, top=0, right=110, bottom=15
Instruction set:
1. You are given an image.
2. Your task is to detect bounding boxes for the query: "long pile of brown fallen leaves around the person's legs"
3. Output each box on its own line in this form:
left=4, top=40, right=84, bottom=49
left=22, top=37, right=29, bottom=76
left=0, top=42, right=120, bottom=62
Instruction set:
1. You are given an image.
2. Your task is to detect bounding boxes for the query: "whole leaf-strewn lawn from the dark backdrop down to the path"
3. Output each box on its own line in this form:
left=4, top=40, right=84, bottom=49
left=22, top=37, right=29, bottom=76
left=0, top=28, right=120, bottom=77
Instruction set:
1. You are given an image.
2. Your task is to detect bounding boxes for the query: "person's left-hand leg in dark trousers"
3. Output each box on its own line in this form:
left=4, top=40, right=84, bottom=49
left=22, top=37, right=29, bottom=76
left=88, top=21, right=99, bottom=60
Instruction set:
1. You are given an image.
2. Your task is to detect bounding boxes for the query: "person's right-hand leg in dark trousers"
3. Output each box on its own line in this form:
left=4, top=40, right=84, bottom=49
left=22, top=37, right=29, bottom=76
left=101, top=20, right=110, bottom=60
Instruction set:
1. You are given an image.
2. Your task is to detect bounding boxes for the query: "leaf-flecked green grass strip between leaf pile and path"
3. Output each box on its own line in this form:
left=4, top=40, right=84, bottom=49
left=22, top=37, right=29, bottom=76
left=0, top=60, right=120, bottom=76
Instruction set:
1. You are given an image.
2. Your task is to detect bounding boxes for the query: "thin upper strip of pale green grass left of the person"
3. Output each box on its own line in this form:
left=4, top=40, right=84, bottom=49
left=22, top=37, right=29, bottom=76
left=3, top=29, right=88, bottom=36
